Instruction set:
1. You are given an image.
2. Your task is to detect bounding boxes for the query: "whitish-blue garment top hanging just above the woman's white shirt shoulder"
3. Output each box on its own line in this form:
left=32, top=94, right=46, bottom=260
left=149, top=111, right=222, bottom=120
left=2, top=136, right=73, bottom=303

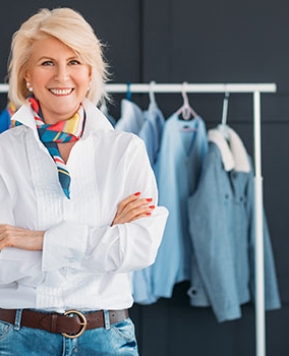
left=114, top=99, right=144, bottom=135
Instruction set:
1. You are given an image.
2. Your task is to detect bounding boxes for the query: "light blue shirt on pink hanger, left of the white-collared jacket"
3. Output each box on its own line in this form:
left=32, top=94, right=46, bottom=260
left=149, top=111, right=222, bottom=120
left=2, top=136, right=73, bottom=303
left=151, top=114, right=208, bottom=298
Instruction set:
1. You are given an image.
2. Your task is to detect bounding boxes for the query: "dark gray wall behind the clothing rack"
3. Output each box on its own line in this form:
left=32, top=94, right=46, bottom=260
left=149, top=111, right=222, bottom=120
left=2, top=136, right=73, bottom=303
left=0, top=0, right=289, bottom=356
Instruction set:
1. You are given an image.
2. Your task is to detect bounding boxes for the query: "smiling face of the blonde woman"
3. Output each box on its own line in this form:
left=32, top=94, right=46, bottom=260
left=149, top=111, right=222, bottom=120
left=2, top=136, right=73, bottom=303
left=25, top=37, right=91, bottom=124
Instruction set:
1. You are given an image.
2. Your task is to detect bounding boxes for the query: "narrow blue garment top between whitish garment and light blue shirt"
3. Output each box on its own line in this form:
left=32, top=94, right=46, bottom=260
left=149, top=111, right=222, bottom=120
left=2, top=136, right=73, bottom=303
left=139, top=102, right=165, bottom=165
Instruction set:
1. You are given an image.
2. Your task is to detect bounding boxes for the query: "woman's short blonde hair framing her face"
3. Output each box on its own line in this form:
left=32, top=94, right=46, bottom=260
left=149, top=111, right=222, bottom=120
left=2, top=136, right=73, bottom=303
left=8, top=8, right=108, bottom=107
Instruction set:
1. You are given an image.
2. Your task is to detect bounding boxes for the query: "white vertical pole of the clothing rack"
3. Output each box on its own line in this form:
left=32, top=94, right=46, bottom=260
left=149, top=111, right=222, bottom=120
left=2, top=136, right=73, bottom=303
left=253, top=91, right=266, bottom=356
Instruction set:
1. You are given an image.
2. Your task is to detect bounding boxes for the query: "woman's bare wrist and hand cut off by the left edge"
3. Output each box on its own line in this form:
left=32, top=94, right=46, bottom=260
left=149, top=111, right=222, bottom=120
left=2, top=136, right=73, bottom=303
left=0, top=224, right=44, bottom=251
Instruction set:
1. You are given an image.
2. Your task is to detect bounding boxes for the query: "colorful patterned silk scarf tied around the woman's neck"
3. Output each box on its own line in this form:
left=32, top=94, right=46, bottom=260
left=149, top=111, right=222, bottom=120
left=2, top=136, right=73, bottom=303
left=12, top=96, right=86, bottom=199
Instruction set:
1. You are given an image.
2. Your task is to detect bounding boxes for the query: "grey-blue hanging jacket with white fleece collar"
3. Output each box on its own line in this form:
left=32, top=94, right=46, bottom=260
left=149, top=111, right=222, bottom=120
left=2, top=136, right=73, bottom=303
left=188, top=129, right=280, bottom=322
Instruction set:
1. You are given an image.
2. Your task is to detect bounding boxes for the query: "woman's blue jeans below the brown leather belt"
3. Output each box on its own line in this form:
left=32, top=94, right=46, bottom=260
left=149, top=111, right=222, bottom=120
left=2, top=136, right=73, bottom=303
left=0, top=310, right=138, bottom=356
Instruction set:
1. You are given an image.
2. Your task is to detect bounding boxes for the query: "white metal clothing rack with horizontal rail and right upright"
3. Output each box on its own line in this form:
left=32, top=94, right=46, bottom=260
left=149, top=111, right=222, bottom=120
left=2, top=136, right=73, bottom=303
left=0, top=82, right=277, bottom=356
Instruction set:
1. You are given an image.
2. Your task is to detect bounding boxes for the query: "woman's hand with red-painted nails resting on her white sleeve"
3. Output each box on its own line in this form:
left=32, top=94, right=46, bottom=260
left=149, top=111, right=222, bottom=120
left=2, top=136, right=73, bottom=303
left=111, top=192, right=155, bottom=226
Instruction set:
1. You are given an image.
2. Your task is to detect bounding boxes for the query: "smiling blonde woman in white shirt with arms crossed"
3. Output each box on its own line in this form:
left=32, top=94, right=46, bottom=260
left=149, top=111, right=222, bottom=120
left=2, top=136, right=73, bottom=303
left=0, top=8, right=167, bottom=356
